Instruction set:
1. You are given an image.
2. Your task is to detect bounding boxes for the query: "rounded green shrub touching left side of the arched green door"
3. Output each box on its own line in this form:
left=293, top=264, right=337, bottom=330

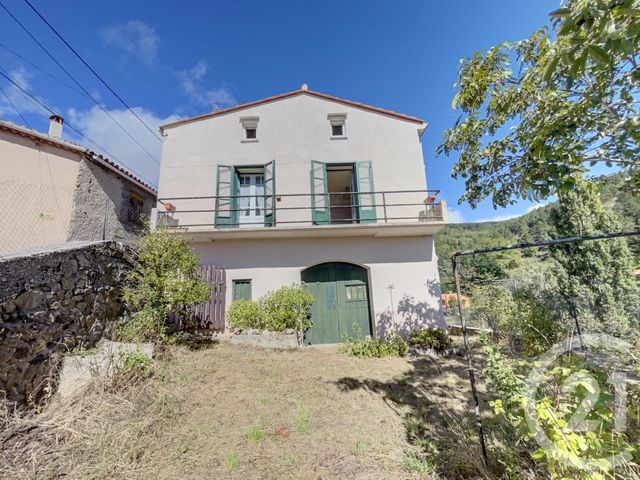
left=260, top=284, right=314, bottom=332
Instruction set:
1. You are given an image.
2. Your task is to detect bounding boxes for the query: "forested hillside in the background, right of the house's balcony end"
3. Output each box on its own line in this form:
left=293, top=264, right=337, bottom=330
left=436, top=174, right=640, bottom=291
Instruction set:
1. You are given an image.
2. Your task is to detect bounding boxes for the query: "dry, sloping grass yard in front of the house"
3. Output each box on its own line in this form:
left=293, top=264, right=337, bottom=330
left=0, top=344, right=492, bottom=480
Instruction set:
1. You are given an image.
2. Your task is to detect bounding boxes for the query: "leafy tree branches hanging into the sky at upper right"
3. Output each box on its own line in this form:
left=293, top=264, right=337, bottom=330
left=438, top=0, right=640, bottom=207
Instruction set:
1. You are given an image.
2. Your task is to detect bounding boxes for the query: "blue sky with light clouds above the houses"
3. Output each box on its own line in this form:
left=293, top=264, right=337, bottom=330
left=0, top=0, right=559, bottom=221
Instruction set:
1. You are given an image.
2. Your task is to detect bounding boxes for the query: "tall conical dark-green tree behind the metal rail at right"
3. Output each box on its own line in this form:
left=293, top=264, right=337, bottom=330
left=550, top=180, right=640, bottom=336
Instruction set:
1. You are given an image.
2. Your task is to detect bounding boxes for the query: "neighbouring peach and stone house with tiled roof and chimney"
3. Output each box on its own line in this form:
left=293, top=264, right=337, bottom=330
left=0, top=115, right=156, bottom=255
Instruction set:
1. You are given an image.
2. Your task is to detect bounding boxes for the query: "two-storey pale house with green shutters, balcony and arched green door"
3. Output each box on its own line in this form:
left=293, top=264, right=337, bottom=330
left=158, top=85, right=446, bottom=343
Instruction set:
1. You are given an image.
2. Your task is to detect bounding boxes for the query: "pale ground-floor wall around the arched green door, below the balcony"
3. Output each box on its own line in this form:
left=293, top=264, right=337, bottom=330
left=194, top=237, right=445, bottom=337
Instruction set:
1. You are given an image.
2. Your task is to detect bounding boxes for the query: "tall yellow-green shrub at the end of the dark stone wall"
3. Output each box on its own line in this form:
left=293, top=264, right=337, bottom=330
left=120, top=230, right=209, bottom=341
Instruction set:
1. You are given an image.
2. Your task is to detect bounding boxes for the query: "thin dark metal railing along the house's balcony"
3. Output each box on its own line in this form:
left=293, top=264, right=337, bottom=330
left=158, top=190, right=445, bottom=228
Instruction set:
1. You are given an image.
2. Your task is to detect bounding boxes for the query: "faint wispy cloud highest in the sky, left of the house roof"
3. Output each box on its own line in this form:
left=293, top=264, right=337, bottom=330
left=100, top=20, right=160, bottom=65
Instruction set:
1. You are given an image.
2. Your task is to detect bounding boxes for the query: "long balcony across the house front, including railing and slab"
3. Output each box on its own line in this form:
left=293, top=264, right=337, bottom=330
left=156, top=190, right=447, bottom=239
